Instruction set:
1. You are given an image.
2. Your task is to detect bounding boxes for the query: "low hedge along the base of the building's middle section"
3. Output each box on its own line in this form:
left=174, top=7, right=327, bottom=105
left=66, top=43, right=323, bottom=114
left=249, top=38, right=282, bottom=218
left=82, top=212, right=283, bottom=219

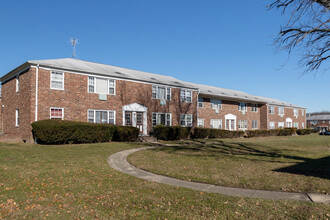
left=191, top=128, right=244, bottom=139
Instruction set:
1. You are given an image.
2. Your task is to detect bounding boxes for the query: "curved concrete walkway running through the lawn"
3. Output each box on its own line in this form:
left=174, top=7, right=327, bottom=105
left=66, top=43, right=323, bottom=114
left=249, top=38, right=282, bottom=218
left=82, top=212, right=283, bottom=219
left=108, top=147, right=330, bottom=204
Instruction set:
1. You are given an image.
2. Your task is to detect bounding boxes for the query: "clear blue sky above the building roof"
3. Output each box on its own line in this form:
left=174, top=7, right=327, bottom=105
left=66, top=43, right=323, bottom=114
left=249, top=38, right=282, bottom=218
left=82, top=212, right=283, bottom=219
left=0, top=0, right=330, bottom=112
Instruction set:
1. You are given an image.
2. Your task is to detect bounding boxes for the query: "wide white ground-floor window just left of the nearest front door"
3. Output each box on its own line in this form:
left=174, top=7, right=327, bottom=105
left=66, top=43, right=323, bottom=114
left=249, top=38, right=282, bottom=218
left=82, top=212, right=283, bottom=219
left=87, top=109, right=116, bottom=124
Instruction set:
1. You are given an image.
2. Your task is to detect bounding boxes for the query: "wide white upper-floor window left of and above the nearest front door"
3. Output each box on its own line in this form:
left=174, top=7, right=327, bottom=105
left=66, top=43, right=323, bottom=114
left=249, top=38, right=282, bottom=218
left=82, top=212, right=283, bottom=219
left=88, top=76, right=116, bottom=95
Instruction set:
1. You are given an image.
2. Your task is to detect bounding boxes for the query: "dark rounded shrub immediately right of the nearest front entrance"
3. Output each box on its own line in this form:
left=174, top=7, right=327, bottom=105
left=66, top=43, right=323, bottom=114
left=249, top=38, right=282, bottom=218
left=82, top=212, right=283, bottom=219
left=153, top=125, right=191, bottom=140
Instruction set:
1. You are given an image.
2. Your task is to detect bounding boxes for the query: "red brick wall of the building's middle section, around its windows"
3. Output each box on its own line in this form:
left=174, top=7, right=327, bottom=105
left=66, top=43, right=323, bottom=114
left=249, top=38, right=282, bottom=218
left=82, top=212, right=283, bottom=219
left=198, top=97, right=262, bottom=130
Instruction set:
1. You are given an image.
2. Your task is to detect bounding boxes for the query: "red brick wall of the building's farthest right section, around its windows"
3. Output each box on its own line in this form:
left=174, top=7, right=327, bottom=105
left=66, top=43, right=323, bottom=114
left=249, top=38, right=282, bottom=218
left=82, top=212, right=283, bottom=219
left=267, top=105, right=306, bottom=128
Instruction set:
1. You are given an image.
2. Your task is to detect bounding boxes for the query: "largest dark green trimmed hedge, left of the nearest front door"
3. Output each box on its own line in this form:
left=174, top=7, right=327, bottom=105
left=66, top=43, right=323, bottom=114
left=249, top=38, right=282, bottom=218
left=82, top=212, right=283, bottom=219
left=31, top=119, right=139, bottom=144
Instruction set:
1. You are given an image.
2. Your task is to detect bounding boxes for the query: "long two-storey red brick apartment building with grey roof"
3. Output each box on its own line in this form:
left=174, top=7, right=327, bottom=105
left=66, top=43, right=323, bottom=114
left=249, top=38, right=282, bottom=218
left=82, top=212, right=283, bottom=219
left=0, top=58, right=306, bottom=141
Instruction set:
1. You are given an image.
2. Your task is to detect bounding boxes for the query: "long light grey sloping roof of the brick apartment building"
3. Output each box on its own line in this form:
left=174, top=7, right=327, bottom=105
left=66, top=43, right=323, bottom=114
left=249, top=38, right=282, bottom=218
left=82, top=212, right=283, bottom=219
left=0, top=58, right=303, bottom=108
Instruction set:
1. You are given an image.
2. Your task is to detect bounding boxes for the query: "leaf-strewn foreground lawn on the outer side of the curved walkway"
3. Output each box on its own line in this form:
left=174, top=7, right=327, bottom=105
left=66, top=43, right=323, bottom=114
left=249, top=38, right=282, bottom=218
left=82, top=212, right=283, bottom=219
left=0, top=140, right=330, bottom=219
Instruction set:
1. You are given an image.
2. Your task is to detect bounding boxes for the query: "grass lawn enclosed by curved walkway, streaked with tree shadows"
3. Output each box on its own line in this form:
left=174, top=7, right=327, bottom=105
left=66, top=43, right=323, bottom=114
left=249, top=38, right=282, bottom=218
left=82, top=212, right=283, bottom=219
left=128, top=134, right=330, bottom=193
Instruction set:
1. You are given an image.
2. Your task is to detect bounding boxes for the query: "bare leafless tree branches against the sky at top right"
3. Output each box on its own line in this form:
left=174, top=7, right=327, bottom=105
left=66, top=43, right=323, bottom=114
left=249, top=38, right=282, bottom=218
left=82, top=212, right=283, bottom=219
left=269, top=0, right=330, bottom=72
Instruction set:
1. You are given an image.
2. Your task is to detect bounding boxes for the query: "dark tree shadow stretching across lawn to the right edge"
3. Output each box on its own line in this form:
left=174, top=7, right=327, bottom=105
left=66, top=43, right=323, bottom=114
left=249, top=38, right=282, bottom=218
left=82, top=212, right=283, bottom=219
left=159, top=140, right=330, bottom=179
